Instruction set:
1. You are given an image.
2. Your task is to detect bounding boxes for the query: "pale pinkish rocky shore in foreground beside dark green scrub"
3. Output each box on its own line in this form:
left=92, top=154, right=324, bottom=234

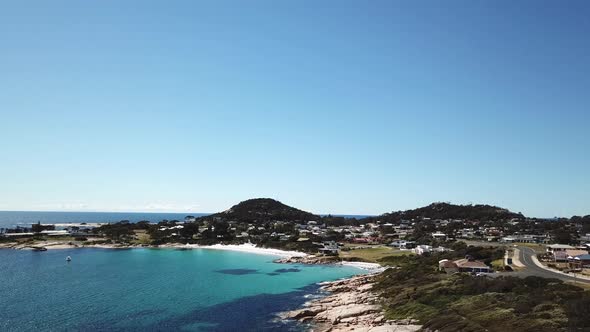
left=281, top=274, right=421, bottom=332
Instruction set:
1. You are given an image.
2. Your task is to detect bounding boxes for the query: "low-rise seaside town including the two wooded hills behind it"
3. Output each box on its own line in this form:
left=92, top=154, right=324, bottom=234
left=0, top=199, right=590, bottom=268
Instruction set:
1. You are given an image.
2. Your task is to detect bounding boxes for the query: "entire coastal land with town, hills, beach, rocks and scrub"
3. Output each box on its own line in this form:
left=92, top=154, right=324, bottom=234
left=0, top=199, right=590, bottom=331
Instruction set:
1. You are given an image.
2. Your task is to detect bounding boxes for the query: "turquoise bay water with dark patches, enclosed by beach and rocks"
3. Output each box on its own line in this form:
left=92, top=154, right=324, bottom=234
left=0, top=249, right=362, bottom=331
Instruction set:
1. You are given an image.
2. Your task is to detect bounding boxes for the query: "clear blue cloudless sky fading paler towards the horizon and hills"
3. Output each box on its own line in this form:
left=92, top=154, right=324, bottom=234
left=0, top=0, right=590, bottom=217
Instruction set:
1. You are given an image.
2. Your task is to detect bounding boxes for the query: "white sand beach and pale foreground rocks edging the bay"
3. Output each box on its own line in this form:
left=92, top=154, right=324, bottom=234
left=0, top=241, right=404, bottom=332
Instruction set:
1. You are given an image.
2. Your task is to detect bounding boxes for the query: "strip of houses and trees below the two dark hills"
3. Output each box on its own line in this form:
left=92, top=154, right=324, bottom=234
left=0, top=216, right=590, bottom=261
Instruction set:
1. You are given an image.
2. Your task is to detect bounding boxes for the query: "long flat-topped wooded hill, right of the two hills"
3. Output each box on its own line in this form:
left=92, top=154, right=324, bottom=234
left=370, top=203, right=525, bottom=222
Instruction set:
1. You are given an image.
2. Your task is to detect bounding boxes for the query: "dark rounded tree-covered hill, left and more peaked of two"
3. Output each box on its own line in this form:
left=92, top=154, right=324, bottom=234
left=202, top=198, right=321, bottom=222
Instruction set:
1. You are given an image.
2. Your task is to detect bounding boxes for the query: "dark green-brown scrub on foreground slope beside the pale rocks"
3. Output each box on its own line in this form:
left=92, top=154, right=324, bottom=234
left=375, top=247, right=590, bottom=332
